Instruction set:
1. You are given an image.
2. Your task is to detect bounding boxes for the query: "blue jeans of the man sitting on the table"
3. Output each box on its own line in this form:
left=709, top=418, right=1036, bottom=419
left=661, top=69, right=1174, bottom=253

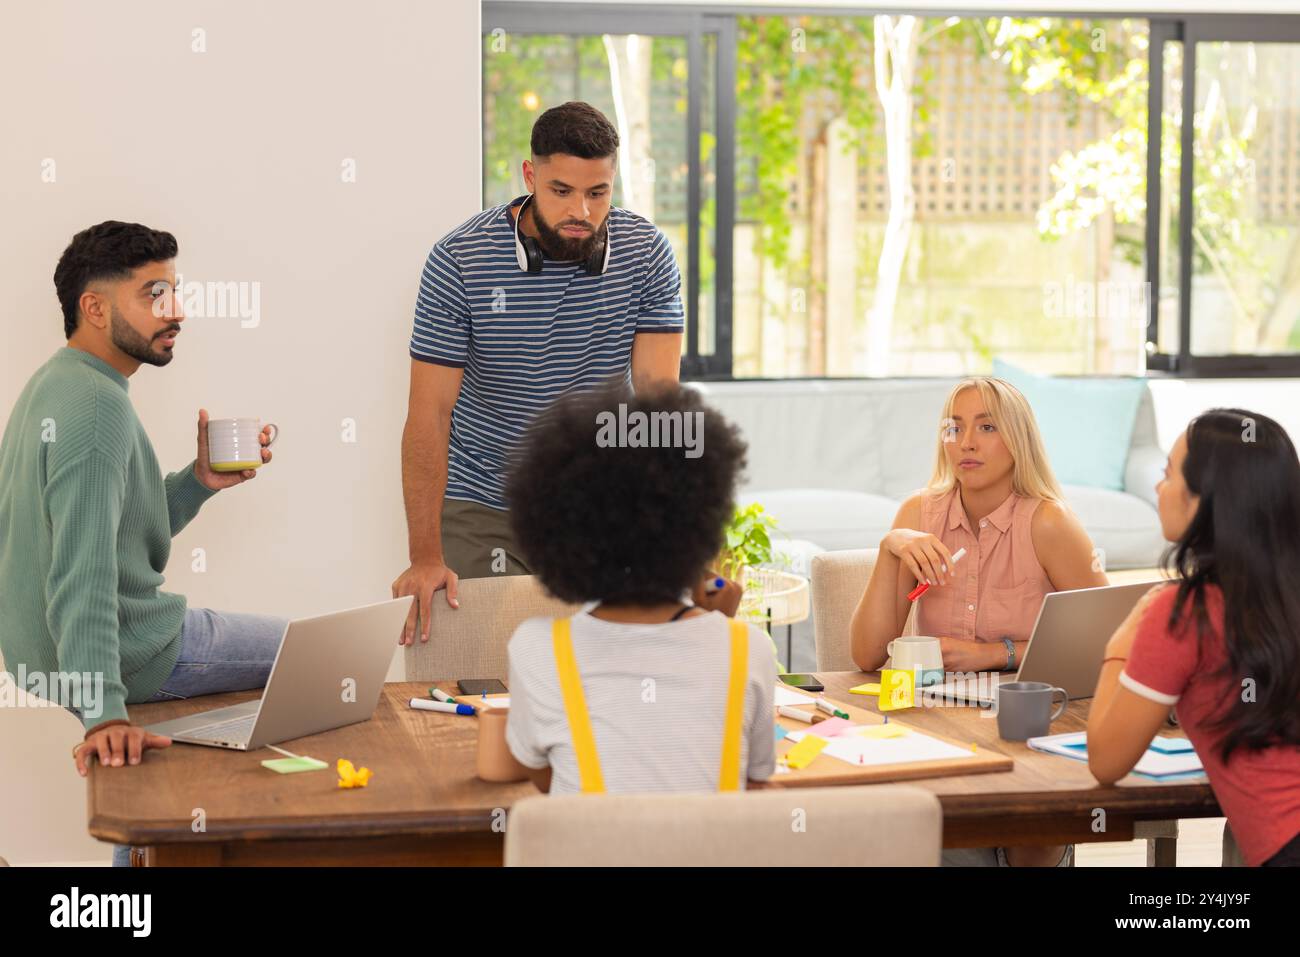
left=113, top=609, right=287, bottom=867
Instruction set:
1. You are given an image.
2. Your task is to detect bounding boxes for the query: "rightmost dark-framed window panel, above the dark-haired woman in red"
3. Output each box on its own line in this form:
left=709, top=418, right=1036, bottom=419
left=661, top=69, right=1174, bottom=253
left=1148, top=17, right=1300, bottom=376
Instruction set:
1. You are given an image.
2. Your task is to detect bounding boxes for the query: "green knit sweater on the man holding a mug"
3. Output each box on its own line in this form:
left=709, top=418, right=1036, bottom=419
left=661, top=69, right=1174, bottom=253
left=0, top=346, right=215, bottom=729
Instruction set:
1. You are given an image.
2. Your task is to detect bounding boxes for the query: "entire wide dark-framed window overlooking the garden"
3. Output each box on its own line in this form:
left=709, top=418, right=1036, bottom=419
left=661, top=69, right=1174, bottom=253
left=484, top=3, right=1300, bottom=378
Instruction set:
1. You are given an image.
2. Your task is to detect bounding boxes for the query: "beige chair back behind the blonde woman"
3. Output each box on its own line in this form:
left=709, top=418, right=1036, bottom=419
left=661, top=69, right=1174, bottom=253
left=810, top=549, right=1178, bottom=867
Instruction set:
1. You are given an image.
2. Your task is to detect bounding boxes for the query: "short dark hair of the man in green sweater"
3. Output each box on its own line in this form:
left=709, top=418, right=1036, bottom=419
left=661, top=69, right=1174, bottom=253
left=55, top=220, right=177, bottom=339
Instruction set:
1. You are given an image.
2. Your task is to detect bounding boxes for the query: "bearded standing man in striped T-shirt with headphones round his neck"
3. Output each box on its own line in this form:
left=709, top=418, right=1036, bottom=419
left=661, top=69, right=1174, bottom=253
left=393, top=103, right=684, bottom=644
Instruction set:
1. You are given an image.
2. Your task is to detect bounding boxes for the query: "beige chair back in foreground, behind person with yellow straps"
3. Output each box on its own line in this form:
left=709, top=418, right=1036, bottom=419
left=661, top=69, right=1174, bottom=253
left=506, top=784, right=944, bottom=867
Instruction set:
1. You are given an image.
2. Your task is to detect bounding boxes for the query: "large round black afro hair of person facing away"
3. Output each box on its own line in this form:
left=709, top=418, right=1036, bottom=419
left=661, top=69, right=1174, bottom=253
left=506, top=384, right=745, bottom=605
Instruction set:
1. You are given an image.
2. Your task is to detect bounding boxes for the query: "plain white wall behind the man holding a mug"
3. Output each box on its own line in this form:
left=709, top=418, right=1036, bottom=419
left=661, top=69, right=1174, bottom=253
left=0, top=0, right=482, bottom=674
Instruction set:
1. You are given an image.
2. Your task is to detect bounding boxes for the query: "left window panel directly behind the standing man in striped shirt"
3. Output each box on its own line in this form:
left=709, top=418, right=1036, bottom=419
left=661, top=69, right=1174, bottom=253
left=484, top=11, right=735, bottom=376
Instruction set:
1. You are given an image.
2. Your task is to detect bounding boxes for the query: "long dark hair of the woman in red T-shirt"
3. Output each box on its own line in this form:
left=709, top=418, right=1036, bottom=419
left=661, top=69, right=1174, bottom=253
left=1165, top=408, right=1300, bottom=762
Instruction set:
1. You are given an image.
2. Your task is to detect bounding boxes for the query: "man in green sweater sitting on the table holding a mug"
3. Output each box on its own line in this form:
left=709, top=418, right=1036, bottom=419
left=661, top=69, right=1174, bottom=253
left=0, top=222, right=285, bottom=790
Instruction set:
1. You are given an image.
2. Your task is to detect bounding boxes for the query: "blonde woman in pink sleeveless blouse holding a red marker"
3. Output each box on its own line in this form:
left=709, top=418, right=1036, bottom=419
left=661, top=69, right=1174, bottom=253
left=852, top=377, right=1108, bottom=866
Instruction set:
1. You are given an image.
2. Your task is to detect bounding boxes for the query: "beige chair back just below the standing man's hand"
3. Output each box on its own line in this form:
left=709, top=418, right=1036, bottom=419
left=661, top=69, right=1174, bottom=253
left=406, top=575, right=581, bottom=681
